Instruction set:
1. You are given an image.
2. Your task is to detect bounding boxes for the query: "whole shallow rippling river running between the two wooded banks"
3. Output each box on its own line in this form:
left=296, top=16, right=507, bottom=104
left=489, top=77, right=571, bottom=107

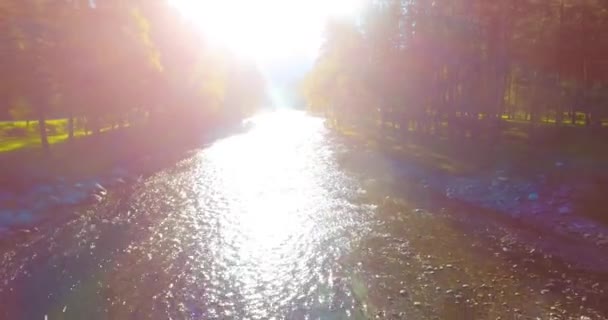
left=0, top=112, right=608, bottom=320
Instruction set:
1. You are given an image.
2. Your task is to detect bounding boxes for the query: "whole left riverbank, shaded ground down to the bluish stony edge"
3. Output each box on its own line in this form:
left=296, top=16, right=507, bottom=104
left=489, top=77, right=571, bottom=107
left=0, top=119, right=247, bottom=238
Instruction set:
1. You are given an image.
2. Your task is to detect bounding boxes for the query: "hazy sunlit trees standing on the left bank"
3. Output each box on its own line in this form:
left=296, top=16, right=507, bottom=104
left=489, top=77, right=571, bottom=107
left=0, top=0, right=265, bottom=148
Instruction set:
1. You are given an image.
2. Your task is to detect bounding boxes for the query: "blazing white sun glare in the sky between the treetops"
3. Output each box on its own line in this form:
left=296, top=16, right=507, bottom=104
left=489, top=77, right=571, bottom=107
left=168, top=0, right=365, bottom=63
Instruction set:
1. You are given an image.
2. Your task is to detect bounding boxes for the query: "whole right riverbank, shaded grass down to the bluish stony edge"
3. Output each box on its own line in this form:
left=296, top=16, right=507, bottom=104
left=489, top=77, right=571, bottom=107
left=338, top=122, right=608, bottom=252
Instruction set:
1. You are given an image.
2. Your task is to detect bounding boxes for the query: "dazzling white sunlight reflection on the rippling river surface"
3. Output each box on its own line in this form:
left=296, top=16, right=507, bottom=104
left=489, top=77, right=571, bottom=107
left=132, top=111, right=370, bottom=319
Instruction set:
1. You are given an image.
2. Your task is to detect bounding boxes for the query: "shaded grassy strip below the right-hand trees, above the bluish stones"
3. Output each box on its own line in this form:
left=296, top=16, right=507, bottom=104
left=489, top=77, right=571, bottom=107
left=339, top=117, right=608, bottom=177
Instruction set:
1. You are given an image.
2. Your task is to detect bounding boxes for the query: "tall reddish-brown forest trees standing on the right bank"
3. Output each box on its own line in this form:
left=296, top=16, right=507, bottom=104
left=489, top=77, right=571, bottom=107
left=303, top=0, right=608, bottom=144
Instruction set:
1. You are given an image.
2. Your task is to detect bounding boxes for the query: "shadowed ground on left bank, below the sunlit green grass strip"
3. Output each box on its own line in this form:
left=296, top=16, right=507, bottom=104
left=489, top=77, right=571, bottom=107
left=0, top=124, right=248, bottom=192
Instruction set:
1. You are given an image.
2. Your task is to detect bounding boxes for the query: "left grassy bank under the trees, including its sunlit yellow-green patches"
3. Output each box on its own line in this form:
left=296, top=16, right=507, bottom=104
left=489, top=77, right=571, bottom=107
left=0, top=117, right=199, bottom=190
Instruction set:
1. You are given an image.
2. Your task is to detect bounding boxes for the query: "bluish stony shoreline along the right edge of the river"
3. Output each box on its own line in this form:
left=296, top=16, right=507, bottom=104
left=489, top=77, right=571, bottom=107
left=332, top=125, right=608, bottom=266
